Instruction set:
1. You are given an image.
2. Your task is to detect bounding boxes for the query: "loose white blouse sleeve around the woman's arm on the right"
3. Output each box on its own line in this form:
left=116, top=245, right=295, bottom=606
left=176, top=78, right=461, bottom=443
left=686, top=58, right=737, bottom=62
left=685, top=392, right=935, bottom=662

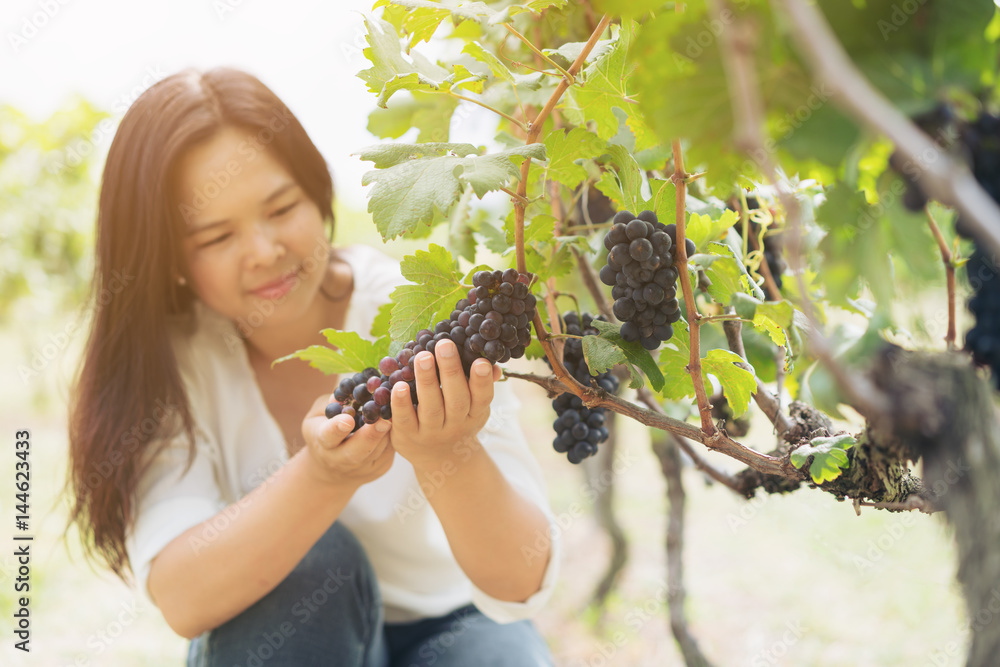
left=472, top=382, right=562, bottom=623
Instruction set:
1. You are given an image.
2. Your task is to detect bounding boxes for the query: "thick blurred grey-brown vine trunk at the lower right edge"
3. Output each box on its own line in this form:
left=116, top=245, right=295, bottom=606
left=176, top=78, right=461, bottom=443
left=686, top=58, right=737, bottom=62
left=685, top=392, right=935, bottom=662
left=873, top=347, right=1000, bottom=667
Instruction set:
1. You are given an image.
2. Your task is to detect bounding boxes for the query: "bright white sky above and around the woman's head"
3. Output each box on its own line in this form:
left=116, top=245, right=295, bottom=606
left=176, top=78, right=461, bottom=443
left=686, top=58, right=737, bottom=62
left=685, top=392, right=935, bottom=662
left=0, top=0, right=412, bottom=209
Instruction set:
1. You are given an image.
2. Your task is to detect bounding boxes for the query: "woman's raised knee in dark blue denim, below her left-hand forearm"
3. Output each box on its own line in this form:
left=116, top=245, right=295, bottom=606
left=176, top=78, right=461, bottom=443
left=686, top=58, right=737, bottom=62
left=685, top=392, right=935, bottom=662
left=188, top=521, right=382, bottom=667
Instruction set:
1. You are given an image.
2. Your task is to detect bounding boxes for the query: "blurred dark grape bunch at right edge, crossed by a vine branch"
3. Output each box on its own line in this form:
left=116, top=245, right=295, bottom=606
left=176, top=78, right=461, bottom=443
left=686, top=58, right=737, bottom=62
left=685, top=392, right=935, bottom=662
left=955, top=113, right=1000, bottom=389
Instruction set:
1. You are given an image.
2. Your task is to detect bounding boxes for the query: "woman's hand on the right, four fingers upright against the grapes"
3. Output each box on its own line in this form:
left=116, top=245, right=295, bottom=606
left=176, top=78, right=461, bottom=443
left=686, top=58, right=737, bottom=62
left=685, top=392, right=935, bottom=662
left=389, top=340, right=500, bottom=471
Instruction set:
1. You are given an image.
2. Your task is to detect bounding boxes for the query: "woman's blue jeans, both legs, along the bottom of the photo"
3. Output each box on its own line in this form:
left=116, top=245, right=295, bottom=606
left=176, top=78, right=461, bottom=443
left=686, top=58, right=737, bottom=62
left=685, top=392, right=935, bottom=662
left=187, top=521, right=552, bottom=667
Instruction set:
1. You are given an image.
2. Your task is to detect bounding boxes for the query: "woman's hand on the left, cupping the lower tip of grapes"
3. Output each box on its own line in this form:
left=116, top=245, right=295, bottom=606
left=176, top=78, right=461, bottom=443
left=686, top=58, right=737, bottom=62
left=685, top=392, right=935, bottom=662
left=302, top=394, right=395, bottom=490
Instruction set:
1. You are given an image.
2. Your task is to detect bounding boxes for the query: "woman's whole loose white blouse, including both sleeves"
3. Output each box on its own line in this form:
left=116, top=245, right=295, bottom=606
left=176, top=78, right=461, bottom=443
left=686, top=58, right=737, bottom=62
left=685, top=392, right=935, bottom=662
left=126, top=245, right=560, bottom=623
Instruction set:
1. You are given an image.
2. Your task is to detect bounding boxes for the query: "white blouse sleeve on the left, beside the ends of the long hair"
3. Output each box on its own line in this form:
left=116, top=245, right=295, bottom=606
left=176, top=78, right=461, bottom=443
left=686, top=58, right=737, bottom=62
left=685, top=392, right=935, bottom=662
left=125, top=406, right=226, bottom=606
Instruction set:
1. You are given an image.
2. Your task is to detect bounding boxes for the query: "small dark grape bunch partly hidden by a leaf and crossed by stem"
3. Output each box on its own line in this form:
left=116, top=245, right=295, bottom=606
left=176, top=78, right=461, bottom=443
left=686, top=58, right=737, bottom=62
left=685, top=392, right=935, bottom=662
left=546, top=312, right=618, bottom=463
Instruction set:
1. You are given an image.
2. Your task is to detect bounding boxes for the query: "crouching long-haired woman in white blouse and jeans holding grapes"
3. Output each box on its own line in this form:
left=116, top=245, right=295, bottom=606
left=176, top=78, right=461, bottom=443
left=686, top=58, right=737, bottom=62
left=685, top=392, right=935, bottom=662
left=68, top=68, right=558, bottom=667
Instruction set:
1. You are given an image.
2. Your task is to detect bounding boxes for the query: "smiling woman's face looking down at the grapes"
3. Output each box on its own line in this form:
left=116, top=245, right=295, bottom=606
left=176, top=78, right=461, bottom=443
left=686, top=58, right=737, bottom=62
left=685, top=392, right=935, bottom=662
left=176, top=127, right=330, bottom=327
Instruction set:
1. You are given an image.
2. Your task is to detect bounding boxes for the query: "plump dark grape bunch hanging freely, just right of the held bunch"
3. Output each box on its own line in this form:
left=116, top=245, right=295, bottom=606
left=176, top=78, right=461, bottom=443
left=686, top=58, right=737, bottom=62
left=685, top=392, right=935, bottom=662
left=600, top=211, right=695, bottom=350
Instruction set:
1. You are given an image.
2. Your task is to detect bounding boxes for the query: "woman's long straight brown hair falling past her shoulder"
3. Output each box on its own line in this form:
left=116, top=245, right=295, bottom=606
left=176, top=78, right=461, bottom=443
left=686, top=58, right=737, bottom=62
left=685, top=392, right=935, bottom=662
left=66, top=68, right=333, bottom=581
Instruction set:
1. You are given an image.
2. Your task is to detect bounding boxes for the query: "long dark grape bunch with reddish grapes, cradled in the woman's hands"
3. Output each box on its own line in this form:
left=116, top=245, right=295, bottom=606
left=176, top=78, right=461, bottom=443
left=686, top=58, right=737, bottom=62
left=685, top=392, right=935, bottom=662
left=326, top=269, right=536, bottom=430
